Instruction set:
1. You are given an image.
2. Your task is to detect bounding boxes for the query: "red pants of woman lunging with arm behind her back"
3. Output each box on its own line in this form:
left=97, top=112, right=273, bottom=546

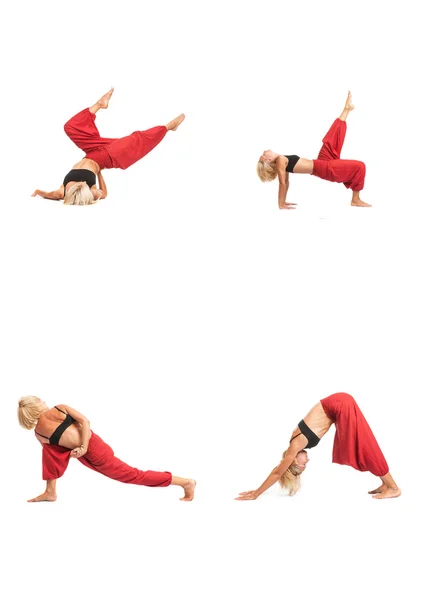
left=43, top=432, right=172, bottom=487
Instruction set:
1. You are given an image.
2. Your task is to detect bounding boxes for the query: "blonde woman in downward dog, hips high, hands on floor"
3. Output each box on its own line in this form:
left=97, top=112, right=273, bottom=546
left=236, top=393, right=401, bottom=500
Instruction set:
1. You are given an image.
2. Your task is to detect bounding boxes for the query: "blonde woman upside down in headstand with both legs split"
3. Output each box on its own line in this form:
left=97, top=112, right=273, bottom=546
left=32, top=88, right=185, bottom=205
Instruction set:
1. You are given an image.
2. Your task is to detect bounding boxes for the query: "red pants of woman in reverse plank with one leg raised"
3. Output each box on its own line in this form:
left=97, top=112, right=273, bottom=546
left=312, top=119, right=365, bottom=192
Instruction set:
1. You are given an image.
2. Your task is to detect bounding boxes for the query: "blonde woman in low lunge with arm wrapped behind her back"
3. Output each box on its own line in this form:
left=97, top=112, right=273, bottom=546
left=18, top=396, right=196, bottom=502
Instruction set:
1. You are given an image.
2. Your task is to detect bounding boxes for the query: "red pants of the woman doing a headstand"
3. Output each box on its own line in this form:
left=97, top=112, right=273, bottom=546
left=65, top=108, right=168, bottom=169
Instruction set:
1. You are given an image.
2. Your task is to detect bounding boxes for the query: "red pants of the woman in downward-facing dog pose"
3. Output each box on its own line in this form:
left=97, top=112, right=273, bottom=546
left=321, top=393, right=389, bottom=477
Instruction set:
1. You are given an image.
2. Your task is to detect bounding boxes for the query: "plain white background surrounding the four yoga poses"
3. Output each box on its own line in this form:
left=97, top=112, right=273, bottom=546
left=0, top=0, right=424, bottom=600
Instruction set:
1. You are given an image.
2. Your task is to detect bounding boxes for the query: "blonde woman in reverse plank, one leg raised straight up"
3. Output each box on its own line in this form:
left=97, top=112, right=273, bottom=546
left=256, top=92, right=371, bottom=209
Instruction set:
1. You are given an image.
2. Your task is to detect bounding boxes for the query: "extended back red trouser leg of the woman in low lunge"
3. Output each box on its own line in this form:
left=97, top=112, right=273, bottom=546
left=78, top=433, right=172, bottom=487
